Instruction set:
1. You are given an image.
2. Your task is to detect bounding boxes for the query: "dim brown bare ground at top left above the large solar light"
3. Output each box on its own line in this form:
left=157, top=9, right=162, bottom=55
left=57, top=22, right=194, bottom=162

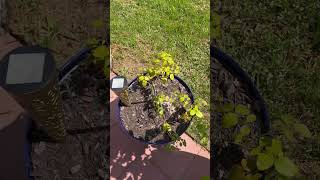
left=6, top=0, right=107, bottom=66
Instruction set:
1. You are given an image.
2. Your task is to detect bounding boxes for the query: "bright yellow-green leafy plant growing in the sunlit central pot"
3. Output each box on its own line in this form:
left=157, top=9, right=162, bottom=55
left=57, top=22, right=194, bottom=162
left=138, top=52, right=207, bottom=150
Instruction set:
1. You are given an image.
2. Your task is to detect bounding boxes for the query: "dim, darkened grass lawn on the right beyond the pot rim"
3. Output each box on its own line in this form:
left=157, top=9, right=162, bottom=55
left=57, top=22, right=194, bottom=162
left=214, top=0, right=320, bottom=179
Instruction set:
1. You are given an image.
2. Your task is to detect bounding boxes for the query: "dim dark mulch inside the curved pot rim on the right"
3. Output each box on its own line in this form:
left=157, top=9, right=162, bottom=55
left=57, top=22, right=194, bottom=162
left=210, top=59, right=261, bottom=179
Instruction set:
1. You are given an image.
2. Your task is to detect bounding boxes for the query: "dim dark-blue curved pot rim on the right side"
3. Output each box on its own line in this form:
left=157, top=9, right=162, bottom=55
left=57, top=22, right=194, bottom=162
left=210, top=45, right=271, bottom=134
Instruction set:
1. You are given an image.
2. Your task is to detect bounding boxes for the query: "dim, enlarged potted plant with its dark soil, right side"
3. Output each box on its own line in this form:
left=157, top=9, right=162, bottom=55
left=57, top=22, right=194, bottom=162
left=211, top=60, right=311, bottom=180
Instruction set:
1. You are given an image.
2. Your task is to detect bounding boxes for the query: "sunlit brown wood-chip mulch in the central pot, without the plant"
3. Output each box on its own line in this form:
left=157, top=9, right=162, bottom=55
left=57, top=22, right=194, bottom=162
left=120, top=80, right=189, bottom=143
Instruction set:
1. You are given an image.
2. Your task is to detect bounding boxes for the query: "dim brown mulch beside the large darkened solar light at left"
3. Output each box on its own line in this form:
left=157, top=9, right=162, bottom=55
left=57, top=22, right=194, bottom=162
left=31, top=60, right=109, bottom=180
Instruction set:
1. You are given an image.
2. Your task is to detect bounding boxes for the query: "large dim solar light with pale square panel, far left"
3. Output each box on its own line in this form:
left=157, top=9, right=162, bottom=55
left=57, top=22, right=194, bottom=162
left=0, top=46, right=66, bottom=141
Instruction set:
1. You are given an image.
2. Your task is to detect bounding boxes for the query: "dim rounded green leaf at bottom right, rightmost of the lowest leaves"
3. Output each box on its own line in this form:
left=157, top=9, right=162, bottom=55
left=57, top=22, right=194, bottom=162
left=274, top=157, right=298, bottom=177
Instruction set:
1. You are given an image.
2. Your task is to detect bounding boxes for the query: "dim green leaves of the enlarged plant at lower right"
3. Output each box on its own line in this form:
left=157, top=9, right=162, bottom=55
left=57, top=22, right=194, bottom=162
left=217, top=103, right=311, bottom=180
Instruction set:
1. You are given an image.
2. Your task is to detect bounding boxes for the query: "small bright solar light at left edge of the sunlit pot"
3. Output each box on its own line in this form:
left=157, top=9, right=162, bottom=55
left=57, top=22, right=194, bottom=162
left=111, top=76, right=131, bottom=106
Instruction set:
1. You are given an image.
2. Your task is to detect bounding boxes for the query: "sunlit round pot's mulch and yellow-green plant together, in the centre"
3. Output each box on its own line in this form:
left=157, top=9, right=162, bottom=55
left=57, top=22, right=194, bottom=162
left=120, top=52, right=206, bottom=150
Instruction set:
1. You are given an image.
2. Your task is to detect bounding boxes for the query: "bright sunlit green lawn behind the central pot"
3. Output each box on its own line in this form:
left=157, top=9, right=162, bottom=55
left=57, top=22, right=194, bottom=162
left=110, top=0, right=210, bottom=147
